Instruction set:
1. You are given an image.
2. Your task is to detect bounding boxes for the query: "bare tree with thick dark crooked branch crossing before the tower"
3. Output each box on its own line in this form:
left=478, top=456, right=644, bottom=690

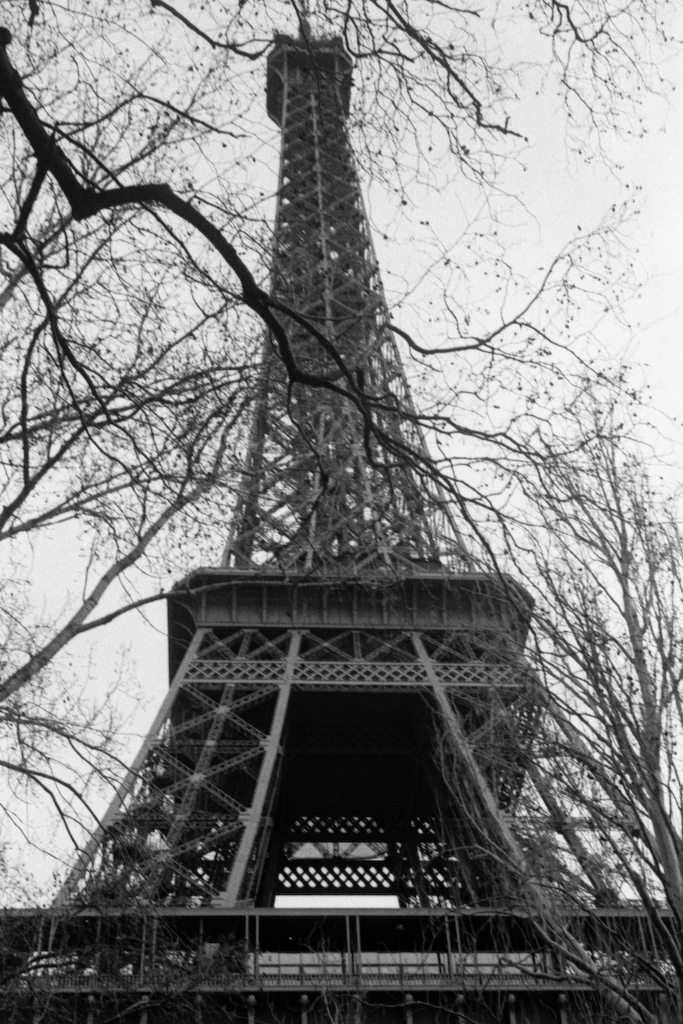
left=0, top=0, right=675, bottom=872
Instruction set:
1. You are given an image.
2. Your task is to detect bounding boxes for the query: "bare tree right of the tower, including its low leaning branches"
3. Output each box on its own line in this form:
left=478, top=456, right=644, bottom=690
left=432, top=387, right=683, bottom=1022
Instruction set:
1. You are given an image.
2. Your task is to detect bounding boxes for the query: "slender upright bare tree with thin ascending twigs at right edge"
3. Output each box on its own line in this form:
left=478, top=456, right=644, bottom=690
left=520, top=396, right=683, bottom=1019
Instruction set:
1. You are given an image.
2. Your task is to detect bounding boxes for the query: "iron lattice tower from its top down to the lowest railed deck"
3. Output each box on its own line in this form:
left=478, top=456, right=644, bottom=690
left=58, top=38, right=528, bottom=907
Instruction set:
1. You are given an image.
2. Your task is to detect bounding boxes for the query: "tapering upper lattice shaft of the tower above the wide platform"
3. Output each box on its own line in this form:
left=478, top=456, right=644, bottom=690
left=226, top=36, right=469, bottom=573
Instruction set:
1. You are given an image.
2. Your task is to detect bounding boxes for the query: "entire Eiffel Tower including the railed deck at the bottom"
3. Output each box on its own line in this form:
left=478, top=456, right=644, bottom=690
left=0, top=33, right=651, bottom=1024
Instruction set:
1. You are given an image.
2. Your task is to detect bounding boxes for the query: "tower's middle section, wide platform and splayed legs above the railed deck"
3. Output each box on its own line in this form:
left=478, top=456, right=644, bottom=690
left=60, top=567, right=539, bottom=908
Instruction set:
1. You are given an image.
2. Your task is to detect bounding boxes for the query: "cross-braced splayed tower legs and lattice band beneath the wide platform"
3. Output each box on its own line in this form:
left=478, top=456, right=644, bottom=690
left=58, top=629, right=529, bottom=906
